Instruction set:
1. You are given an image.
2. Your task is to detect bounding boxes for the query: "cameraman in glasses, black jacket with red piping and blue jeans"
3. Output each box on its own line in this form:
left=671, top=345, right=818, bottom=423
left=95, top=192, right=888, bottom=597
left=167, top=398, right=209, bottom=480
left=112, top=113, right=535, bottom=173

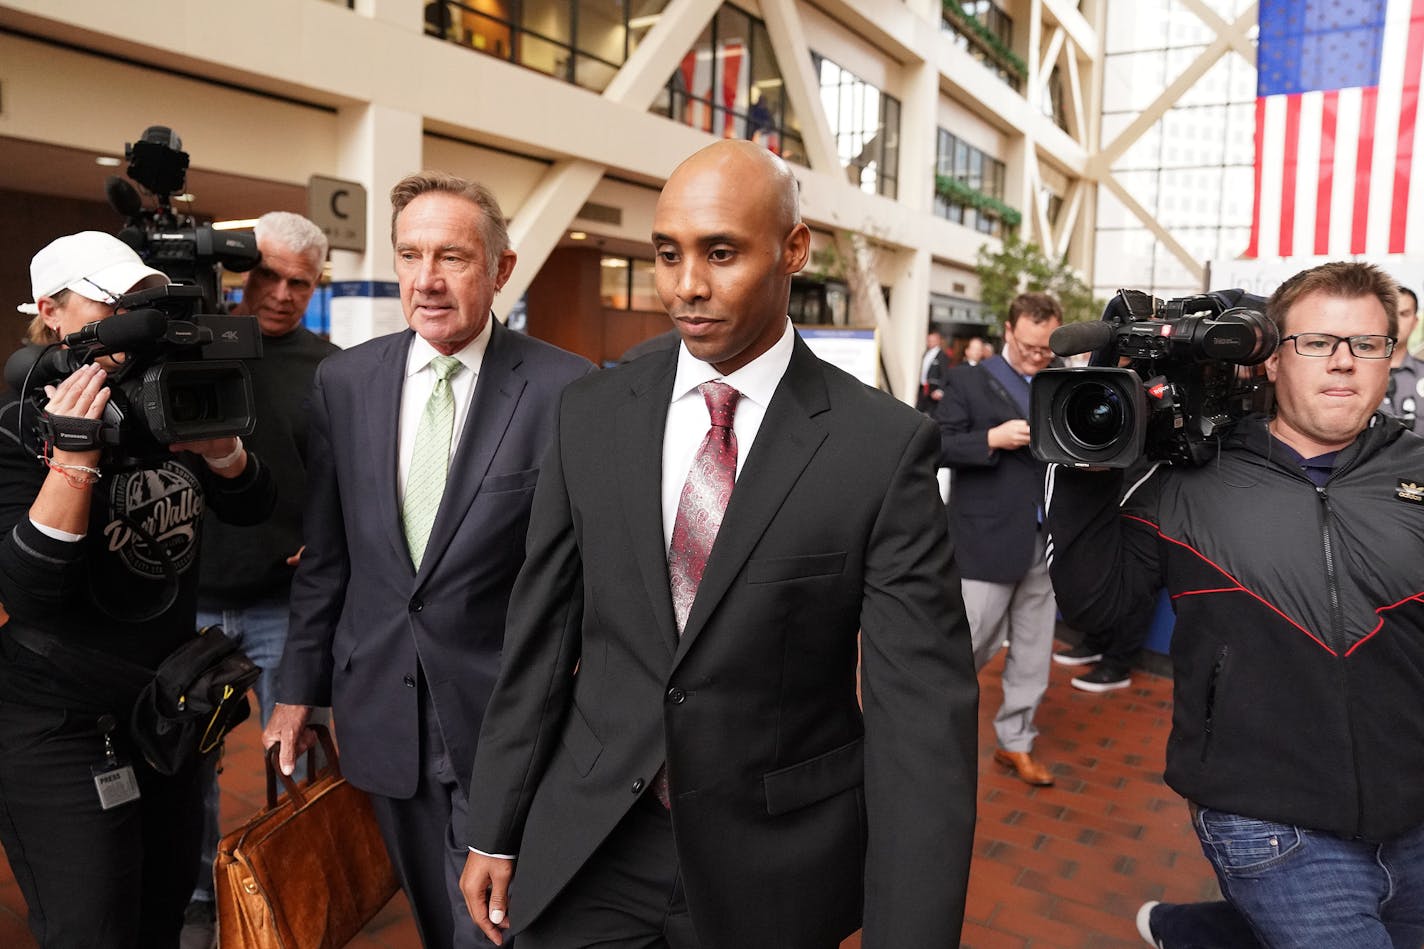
left=1048, top=262, right=1424, bottom=949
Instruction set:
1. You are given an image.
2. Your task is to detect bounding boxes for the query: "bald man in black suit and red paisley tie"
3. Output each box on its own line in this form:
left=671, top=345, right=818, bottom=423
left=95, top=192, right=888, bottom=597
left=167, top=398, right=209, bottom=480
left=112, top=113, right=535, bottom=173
left=461, top=141, right=977, bottom=949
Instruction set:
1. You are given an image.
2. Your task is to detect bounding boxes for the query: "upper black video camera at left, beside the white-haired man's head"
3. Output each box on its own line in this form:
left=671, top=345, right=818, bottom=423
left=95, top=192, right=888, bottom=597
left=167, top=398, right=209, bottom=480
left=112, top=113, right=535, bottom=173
left=104, top=125, right=261, bottom=312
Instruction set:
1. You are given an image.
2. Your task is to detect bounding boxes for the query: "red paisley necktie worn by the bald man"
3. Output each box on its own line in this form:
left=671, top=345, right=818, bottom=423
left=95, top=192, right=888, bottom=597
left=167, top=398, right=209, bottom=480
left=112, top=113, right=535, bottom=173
left=652, top=382, right=742, bottom=808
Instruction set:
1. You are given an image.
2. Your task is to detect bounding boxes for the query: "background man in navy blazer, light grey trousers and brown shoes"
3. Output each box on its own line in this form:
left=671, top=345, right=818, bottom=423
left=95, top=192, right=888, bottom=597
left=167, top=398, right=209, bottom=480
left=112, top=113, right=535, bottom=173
left=934, top=294, right=1062, bottom=787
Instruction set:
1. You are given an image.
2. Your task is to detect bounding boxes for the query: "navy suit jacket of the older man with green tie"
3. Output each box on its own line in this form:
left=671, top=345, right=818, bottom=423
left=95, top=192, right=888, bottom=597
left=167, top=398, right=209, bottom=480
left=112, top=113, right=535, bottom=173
left=278, top=318, right=591, bottom=798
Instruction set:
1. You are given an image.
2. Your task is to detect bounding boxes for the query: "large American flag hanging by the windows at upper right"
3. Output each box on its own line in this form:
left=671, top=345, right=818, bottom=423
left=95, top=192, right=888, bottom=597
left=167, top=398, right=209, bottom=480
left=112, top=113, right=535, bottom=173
left=1246, top=0, right=1424, bottom=258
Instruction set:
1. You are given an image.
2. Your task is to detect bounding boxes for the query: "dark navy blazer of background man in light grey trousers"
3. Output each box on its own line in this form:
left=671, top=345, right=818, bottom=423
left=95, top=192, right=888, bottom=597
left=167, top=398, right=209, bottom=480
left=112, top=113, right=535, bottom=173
left=934, top=356, right=1047, bottom=583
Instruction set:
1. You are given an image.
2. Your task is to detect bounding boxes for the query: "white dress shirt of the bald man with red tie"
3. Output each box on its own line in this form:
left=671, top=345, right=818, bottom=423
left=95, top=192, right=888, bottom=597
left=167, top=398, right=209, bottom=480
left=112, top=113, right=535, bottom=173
left=662, top=319, right=796, bottom=549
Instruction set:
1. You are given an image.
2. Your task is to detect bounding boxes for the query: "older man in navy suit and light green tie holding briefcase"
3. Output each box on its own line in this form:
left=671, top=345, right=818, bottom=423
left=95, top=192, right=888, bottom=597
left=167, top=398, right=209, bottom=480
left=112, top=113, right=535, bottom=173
left=263, top=172, right=591, bottom=949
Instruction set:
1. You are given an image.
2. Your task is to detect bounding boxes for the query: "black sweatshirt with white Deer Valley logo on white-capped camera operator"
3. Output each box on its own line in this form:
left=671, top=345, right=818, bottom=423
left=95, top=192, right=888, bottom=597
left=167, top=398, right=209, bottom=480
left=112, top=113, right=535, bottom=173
left=0, top=396, right=275, bottom=710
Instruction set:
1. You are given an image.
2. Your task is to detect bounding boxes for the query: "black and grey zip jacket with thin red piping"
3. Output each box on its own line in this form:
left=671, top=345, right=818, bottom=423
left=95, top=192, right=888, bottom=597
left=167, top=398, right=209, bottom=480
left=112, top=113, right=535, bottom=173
left=1048, top=415, right=1424, bottom=841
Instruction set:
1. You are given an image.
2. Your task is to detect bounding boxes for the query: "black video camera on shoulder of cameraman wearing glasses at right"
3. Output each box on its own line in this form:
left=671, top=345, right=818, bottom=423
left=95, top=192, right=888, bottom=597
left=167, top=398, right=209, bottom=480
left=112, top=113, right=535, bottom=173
left=1030, top=289, right=1280, bottom=467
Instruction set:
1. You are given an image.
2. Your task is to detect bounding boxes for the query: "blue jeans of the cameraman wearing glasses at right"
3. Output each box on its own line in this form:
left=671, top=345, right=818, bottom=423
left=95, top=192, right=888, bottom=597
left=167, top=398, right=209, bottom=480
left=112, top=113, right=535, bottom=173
left=1179, top=808, right=1424, bottom=949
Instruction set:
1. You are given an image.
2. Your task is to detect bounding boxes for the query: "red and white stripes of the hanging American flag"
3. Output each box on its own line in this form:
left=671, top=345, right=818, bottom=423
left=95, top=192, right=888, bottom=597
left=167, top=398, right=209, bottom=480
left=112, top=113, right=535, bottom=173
left=1246, top=0, right=1424, bottom=258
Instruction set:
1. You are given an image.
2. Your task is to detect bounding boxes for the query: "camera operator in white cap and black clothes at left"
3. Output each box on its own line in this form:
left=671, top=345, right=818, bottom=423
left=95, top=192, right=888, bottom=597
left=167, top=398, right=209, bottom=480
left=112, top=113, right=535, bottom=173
left=0, top=231, right=273, bottom=949
